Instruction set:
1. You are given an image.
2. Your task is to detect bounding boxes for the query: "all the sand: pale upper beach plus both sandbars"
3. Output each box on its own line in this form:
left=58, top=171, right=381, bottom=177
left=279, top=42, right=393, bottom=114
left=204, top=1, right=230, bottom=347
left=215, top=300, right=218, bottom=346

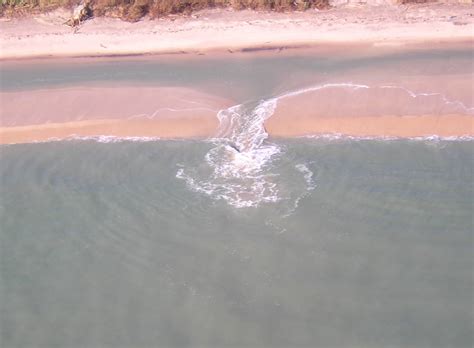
left=0, top=4, right=474, bottom=143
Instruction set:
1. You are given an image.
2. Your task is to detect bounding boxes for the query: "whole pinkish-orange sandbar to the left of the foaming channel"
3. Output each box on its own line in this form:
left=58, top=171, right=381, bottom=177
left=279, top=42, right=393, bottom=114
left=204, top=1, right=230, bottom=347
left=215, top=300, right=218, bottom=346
left=0, top=86, right=232, bottom=143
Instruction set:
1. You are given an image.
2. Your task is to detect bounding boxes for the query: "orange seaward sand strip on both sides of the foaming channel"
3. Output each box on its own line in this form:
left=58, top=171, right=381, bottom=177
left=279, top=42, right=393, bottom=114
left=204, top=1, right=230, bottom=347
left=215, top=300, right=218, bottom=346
left=0, top=115, right=474, bottom=146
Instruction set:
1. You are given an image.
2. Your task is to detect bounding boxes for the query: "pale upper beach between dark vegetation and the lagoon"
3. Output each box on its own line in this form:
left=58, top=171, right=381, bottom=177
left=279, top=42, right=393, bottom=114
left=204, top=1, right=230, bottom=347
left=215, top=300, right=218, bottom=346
left=0, top=4, right=474, bottom=61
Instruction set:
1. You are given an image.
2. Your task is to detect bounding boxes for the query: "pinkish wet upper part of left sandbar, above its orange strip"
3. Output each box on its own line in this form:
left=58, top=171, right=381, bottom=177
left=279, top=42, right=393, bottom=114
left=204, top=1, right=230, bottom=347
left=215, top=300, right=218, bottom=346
left=0, top=85, right=233, bottom=127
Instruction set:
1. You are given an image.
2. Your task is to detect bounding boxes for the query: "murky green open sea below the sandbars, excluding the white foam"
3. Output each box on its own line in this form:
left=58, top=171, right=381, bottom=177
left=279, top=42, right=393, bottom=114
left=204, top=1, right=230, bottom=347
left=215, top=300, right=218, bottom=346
left=1, top=140, right=474, bottom=347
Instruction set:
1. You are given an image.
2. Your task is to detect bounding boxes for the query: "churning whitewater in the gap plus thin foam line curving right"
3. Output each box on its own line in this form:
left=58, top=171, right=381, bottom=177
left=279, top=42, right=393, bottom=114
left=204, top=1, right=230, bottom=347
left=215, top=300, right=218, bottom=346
left=176, top=83, right=474, bottom=208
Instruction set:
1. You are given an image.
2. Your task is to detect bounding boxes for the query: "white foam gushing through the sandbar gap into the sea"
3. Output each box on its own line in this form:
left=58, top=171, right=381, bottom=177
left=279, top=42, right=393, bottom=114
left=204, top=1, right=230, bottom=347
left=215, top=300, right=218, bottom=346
left=176, top=100, right=281, bottom=208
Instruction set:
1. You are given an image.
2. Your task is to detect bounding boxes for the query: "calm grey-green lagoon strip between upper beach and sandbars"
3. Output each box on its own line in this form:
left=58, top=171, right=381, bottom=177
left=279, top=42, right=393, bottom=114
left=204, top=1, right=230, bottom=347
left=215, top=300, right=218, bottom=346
left=0, top=45, right=474, bottom=98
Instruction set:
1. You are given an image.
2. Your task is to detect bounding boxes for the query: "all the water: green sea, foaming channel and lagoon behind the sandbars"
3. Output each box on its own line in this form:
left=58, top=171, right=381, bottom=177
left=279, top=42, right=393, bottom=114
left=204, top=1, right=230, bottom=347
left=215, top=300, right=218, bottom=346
left=0, top=50, right=474, bottom=348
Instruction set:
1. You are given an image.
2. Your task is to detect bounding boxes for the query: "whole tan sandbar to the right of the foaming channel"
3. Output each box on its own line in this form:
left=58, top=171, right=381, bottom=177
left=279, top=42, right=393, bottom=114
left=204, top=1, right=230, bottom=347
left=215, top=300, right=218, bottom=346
left=265, top=81, right=474, bottom=137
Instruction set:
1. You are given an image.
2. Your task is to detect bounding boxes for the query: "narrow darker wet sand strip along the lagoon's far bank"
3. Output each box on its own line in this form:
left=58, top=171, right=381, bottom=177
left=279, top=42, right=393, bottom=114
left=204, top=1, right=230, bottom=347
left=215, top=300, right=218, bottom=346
left=0, top=40, right=474, bottom=67
